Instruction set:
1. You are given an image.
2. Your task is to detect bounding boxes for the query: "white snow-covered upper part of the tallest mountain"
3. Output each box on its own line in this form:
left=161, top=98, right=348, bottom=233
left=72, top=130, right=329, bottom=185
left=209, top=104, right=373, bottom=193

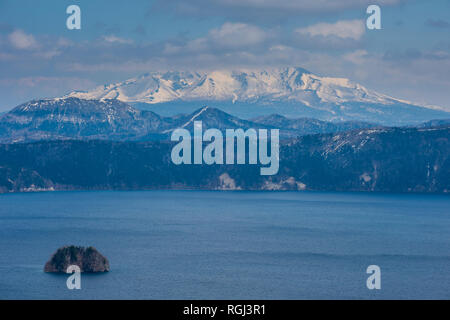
left=68, top=68, right=399, bottom=105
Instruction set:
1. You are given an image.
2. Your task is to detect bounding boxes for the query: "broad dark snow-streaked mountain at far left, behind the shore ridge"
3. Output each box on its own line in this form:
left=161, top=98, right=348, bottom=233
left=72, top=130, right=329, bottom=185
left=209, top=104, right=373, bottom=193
left=0, top=98, right=167, bottom=142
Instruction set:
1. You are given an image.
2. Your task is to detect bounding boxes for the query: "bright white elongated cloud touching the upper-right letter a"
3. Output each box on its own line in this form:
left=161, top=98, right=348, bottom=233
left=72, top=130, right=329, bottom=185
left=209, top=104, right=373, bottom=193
left=295, top=20, right=365, bottom=40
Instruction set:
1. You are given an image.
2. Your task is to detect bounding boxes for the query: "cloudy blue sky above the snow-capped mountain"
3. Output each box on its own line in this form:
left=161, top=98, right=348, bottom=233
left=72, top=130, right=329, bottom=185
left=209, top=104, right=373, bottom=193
left=0, top=0, right=450, bottom=112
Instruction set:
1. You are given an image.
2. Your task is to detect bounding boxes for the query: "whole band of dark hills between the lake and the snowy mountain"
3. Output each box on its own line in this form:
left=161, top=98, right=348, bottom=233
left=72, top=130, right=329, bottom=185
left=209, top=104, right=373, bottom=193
left=0, top=97, right=450, bottom=193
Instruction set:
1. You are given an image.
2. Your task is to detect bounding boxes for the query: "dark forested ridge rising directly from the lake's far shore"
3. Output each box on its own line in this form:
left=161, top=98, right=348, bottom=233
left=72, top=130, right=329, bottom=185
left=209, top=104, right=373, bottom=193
left=0, top=126, right=450, bottom=193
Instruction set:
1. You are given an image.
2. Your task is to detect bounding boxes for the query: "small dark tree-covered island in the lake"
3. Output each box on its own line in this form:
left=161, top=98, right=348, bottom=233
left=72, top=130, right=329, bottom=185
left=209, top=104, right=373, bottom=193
left=44, top=246, right=109, bottom=273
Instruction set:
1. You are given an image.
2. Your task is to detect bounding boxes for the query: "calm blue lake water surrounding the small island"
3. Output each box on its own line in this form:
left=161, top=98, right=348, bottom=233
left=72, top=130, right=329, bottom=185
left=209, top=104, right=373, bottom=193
left=0, top=191, right=450, bottom=299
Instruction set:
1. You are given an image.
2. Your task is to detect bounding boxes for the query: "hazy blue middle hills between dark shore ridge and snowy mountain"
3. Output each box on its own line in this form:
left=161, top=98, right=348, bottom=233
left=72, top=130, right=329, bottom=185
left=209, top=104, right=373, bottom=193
left=0, top=98, right=384, bottom=143
